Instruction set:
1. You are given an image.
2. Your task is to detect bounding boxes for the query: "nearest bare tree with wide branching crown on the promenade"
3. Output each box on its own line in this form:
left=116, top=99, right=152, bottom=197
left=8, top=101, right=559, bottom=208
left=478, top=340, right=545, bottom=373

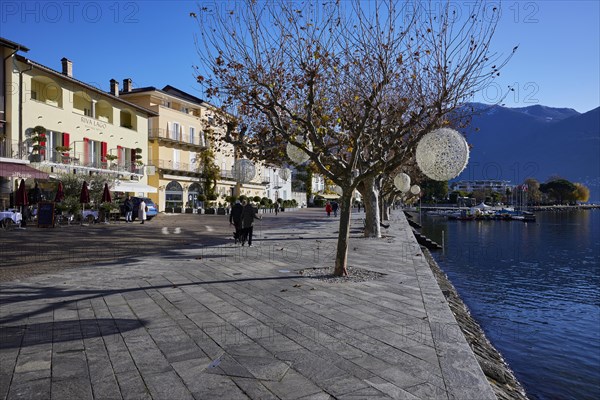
left=191, top=0, right=503, bottom=275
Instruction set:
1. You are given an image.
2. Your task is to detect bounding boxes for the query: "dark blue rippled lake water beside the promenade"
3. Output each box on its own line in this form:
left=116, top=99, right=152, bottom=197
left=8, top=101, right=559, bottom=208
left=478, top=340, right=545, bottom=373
left=422, top=210, right=600, bottom=399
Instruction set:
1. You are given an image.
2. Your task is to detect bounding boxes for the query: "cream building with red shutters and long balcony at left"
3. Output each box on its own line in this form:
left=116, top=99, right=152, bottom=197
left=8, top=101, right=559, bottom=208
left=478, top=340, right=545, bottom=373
left=0, top=39, right=155, bottom=208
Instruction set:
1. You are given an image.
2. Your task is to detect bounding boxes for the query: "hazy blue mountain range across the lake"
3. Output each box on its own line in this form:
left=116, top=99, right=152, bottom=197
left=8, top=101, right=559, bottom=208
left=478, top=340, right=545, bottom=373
left=456, top=103, right=600, bottom=202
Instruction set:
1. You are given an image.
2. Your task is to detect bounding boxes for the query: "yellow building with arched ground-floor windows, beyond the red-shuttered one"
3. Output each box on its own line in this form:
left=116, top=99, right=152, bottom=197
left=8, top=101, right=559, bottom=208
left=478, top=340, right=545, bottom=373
left=120, top=83, right=265, bottom=211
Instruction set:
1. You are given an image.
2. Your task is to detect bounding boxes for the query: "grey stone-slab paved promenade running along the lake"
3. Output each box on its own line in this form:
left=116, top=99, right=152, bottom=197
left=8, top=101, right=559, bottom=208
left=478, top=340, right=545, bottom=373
left=0, top=209, right=495, bottom=400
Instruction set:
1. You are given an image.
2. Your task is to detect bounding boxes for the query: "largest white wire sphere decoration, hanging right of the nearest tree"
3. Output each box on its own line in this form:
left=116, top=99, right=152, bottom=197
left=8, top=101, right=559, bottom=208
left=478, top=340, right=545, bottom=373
left=415, top=128, right=469, bottom=181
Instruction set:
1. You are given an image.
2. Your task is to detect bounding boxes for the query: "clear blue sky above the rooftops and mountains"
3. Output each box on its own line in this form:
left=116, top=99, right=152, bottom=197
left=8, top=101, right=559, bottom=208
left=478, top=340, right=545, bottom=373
left=0, top=0, right=600, bottom=112
